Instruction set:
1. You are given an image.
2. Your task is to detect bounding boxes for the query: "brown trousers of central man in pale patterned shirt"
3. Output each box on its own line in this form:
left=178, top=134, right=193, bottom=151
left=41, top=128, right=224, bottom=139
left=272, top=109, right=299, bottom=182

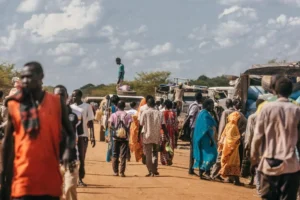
left=144, top=143, right=158, bottom=174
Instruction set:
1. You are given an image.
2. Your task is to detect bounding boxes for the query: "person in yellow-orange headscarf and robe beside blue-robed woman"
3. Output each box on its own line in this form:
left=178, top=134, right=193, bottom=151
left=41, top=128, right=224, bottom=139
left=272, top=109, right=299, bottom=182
left=219, top=111, right=241, bottom=185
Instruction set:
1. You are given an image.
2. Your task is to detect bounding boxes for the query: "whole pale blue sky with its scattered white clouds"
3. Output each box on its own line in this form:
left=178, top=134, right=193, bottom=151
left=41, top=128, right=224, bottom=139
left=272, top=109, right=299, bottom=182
left=0, top=0, right=300, bottom=89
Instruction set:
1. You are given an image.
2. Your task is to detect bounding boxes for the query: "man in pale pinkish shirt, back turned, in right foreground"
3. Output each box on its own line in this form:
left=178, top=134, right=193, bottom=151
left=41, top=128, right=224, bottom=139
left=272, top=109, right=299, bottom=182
left=251, top=77, right=300, bottom=200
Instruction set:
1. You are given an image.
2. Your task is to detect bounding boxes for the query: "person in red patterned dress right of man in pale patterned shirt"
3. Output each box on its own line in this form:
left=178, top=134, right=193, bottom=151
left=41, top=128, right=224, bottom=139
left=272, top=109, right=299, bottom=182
left=160, top=100, right=178, bottom=165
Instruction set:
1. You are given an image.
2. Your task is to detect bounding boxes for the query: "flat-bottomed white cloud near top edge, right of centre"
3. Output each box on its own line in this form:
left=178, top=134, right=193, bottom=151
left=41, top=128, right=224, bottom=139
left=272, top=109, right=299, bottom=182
left=219, top=6, right=257, bottom=19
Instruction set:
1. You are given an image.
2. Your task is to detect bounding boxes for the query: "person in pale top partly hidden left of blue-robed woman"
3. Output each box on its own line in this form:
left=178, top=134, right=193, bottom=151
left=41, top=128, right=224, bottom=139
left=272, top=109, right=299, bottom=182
left=183, top=92, right=202, bottom=175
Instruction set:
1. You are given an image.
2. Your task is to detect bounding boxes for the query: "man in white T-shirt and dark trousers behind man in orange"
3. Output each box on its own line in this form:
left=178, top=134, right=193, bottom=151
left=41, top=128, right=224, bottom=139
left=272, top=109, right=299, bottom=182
left=71, top=90, right=96, bottom=187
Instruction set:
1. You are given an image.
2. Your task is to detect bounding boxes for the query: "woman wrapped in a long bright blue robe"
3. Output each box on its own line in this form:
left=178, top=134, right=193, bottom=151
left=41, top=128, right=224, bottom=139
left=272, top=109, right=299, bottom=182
left=193, top=99, right=217, bottom=180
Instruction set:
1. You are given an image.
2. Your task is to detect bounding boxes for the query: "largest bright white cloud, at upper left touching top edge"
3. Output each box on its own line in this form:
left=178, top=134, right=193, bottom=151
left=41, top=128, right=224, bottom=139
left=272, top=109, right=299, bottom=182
left=24, top=0, right=101, bottom=38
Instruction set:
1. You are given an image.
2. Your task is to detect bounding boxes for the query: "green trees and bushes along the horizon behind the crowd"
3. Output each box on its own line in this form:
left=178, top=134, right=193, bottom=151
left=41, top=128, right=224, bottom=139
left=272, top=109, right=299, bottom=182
left=0, top=63, right=229, bottom=96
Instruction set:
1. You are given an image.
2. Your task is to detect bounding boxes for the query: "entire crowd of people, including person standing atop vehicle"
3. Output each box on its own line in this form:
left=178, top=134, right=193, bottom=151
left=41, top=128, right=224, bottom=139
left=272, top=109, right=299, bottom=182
left=0, top=60, right=300, bottom=200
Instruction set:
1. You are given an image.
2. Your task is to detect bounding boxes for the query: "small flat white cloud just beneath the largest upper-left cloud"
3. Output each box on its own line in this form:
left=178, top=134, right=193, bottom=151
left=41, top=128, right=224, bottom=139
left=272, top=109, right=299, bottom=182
left=47, top=43, right=85, bottom=56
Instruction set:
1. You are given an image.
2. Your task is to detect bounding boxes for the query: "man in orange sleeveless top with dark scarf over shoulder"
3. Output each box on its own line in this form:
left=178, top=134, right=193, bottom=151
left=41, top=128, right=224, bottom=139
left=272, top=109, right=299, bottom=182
left=1, top=62, right=75, bottom=200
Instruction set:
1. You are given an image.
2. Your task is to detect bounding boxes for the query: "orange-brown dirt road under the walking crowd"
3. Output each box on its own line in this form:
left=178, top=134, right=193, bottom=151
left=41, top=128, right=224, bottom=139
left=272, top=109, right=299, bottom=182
left=78, top=125, right=259, bottom=200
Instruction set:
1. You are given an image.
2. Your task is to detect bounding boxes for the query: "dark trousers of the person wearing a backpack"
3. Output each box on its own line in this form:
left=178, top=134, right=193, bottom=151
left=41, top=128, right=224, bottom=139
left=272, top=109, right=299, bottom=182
left=112, top=140, right=128, bottom=173
